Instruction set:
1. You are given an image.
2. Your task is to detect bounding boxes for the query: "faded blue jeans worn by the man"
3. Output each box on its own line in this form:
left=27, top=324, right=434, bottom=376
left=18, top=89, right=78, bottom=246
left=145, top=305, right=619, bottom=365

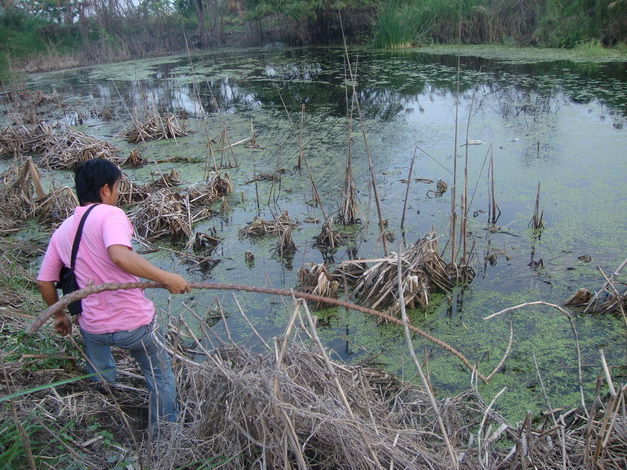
left=81, top=321, right=177, bottom=427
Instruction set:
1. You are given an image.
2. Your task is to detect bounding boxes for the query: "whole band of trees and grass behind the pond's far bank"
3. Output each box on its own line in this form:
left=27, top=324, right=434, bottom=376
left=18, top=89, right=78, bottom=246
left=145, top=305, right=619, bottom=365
left=0, top=0, right=627, bottom=77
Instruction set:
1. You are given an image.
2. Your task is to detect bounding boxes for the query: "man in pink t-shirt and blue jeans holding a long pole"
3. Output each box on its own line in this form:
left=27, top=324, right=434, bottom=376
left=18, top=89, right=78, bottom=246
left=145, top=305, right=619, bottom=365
left=37, top=158, right=191, bottom=430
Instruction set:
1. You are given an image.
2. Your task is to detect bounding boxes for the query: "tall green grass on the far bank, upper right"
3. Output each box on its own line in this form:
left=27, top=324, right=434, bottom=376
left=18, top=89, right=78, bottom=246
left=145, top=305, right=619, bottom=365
left=372, top=0, right=627, bottom=48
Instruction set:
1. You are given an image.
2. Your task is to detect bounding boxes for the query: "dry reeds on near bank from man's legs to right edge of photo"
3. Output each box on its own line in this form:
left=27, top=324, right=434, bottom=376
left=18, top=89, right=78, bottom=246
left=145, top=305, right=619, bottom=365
left=142, top=306, right=627, bottom=470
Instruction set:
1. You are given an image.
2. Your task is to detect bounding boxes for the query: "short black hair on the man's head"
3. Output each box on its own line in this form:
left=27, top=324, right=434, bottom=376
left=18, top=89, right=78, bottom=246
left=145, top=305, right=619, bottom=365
left=74, top=158, right=122, bottom=206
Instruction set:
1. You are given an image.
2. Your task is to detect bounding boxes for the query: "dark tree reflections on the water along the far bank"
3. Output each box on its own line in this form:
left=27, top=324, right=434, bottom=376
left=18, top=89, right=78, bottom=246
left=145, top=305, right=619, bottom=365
left=61, top=49, right=627, bottom=123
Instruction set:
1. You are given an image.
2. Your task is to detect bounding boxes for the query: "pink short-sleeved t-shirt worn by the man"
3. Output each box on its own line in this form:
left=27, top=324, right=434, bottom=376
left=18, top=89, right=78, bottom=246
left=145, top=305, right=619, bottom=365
left=37, top=204, right=155, bottom=334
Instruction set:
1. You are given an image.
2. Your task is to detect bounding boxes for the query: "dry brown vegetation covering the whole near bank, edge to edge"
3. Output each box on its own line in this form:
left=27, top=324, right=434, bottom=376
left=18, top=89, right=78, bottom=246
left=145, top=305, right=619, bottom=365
left=0, top=290, right=627, bottom=470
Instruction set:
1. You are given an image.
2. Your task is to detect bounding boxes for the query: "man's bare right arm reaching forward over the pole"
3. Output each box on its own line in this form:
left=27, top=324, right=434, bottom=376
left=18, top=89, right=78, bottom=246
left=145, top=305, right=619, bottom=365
left=107, top=245, right=192, bottom=294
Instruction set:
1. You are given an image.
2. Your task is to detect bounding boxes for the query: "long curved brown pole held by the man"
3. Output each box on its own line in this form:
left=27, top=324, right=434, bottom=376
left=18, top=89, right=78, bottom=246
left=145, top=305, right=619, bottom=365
left=26, top=281, right=496, bottom=383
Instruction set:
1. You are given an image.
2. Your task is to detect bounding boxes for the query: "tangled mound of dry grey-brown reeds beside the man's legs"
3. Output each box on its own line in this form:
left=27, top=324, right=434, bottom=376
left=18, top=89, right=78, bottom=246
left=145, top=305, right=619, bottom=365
left=152, top=345, right=443, bottom=469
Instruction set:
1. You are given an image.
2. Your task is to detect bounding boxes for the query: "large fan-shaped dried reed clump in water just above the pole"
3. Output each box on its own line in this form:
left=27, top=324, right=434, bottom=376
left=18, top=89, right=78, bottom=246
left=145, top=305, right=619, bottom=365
left=352, top=233, right=452, bottom=314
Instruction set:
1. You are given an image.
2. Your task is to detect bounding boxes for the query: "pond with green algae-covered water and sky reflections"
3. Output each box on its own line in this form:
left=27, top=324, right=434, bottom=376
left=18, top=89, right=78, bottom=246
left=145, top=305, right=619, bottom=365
left=11, top=47, right=627, bottom=420
